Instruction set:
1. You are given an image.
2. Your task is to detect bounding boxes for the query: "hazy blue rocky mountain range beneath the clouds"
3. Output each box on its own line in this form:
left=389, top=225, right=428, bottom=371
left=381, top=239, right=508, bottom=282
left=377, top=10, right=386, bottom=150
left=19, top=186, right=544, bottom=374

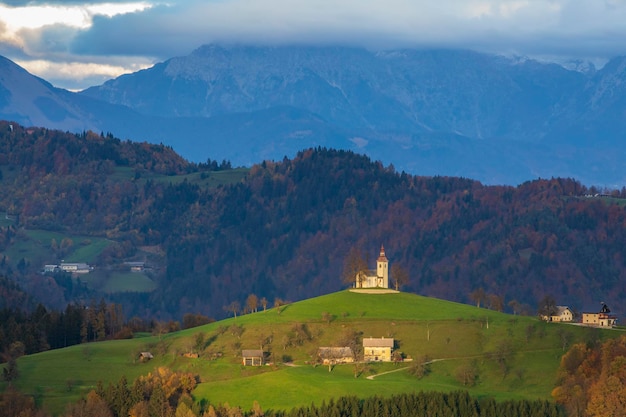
left=0, top=45, right=626, bottom=187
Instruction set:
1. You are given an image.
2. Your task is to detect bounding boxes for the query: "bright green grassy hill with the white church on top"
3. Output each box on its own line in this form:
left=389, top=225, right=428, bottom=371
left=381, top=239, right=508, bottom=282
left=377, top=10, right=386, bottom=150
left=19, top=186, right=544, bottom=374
left=1, top=291, right=619, bottom=411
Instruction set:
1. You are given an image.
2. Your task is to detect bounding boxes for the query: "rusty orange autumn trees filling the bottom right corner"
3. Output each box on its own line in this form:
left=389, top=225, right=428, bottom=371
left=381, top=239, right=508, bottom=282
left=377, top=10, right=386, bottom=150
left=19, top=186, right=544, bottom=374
left=552, top=336, right=626, bottom=417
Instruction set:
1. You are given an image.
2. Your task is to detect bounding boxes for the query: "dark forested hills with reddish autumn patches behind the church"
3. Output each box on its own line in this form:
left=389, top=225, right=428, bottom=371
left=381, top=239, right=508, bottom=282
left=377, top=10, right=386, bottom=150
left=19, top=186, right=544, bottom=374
left=0, top=123, right=626, bottom=318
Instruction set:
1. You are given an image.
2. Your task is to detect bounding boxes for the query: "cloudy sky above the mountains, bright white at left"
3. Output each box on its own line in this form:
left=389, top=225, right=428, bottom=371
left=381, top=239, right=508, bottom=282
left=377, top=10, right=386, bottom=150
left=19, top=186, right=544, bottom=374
left=0, top=0, right=626, bottom=90
